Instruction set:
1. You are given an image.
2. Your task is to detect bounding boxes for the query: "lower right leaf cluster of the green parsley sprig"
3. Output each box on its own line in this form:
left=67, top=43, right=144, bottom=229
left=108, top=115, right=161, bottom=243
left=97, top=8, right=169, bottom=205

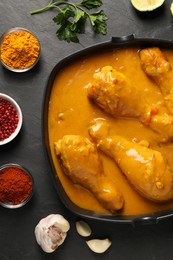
left=90, top=10, right=108, bottom=35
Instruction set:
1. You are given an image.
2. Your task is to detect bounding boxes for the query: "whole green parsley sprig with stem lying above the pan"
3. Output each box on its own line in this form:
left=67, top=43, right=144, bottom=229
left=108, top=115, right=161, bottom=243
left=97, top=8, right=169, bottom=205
left=31, top=0, right=108, bottom=42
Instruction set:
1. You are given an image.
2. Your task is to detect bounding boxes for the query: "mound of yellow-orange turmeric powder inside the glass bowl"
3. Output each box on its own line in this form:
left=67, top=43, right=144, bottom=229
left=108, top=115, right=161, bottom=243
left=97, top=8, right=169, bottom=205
left=1, top=31, right=40, bottom=69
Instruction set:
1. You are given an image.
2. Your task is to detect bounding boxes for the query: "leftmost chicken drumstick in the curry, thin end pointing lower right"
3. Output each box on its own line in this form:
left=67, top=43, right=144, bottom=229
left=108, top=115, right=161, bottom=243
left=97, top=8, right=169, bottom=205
left=55, top=135, right=124, bottom=212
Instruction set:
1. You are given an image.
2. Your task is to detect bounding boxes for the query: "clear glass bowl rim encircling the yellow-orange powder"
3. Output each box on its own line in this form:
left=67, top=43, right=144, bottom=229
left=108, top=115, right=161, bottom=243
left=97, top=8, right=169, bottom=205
left=0, top=27, right=41, bottom=73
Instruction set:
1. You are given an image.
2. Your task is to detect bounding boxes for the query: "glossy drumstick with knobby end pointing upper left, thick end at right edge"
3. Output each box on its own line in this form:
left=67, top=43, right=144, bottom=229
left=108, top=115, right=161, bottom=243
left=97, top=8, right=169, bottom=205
left=89, top=120, right=173, bottom=202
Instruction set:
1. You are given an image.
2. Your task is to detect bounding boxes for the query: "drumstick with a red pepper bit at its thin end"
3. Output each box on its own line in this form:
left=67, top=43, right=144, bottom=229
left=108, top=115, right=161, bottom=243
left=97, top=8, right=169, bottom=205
left=87, top=66, right=173, bottom=142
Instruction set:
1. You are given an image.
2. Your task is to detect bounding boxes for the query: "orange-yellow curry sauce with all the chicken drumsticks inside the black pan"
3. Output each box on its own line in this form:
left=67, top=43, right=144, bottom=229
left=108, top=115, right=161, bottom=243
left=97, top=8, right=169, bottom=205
left=48, top=47, right=173, bottom=215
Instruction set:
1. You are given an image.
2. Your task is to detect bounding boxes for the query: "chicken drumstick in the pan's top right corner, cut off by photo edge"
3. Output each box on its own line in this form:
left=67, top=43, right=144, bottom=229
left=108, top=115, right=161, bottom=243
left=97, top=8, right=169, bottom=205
left=139, top=47, right=173, bottom=114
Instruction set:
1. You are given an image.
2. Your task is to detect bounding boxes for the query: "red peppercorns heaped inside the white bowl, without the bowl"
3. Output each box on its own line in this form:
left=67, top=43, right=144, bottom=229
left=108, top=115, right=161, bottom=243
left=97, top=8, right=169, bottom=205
left=0, top=98, right=19, bottom=141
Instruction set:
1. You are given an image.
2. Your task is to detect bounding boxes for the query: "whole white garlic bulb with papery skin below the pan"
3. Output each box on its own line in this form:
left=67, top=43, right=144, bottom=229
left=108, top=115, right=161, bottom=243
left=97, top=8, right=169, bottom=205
left=35, top=214, right=70, bottom=253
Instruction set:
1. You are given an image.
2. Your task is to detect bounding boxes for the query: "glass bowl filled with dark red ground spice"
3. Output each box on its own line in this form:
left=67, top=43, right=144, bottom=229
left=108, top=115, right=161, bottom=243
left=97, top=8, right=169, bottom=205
left=0, top=164, right=33, bottom=208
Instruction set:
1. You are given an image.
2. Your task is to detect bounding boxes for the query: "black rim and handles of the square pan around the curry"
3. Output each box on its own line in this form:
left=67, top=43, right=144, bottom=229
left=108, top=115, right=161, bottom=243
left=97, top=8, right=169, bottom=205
left=42, top=35, right=173, bottom=225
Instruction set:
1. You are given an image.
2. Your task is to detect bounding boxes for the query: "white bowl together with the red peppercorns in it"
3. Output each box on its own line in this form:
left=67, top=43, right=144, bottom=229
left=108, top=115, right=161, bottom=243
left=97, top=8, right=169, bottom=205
left=0, top=93, right=23, bottom=145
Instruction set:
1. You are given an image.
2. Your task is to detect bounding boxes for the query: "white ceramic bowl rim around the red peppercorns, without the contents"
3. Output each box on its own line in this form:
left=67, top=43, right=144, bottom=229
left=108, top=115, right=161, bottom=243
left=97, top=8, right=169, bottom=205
left=0, top=93, right=23, bottom=145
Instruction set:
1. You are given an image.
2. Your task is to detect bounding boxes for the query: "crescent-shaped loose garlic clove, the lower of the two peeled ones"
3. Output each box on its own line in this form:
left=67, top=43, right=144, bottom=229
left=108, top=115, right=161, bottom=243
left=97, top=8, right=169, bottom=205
left=86, top=238, right=112, bottom=254
